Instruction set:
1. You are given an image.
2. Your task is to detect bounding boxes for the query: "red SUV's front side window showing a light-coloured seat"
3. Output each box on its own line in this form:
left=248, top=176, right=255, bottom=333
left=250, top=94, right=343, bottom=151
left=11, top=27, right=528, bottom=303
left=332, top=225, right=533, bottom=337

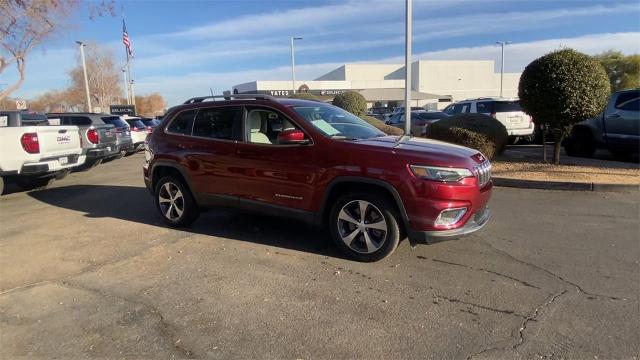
left=245, top=108, right=300, bottom=145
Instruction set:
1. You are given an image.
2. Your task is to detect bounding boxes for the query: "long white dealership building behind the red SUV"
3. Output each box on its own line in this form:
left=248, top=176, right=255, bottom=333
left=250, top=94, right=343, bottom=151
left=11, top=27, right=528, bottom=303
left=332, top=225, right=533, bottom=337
left=231, top=60, right=520, bottom=109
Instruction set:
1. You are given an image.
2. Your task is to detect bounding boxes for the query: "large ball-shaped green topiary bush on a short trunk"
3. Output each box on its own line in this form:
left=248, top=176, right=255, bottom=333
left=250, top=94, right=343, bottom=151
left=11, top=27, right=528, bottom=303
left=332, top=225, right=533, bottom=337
left=518, top=49, right=611, bottom=164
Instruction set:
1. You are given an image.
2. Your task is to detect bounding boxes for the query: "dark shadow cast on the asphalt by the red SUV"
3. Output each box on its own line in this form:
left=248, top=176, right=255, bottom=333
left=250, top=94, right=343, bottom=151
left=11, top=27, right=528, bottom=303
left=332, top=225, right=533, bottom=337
left=28, top=185, right=343, bottom=258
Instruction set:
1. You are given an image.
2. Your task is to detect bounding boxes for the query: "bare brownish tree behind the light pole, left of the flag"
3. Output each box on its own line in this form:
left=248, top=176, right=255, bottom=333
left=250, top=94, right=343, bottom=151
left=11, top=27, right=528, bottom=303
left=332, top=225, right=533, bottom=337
left=67, top=44, right=122, bottom=111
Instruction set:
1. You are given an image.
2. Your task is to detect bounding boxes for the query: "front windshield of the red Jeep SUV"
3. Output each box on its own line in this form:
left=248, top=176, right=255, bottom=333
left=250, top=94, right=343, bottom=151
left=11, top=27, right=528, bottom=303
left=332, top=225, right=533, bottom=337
left=293, top=104, right=384, bottom=139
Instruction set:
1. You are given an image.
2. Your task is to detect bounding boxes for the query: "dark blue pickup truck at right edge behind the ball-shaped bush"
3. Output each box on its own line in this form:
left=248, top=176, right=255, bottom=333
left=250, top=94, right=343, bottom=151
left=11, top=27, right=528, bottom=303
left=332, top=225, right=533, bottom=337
left=564, top=89, right=640, bottom=157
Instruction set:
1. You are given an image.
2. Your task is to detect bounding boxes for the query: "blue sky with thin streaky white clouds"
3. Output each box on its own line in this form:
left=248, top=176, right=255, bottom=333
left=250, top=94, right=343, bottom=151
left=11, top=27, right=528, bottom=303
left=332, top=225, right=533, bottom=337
left=6, top=0, right=640, bottom=105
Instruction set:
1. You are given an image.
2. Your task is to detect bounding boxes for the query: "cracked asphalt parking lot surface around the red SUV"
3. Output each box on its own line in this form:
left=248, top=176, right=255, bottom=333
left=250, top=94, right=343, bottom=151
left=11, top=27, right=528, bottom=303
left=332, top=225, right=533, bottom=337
left=0, top=154, right=640, bottom=359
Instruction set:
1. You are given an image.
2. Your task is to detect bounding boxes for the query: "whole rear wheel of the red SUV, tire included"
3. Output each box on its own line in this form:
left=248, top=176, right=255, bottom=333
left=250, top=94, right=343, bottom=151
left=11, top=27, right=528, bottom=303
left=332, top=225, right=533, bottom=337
left=155, top=176, right=200, bottom=227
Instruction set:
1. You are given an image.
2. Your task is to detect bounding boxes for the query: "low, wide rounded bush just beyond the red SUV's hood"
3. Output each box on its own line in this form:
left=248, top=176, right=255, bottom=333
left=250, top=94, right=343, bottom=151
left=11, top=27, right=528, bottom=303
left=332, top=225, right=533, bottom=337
left=427, top=113, right=509, bottom=159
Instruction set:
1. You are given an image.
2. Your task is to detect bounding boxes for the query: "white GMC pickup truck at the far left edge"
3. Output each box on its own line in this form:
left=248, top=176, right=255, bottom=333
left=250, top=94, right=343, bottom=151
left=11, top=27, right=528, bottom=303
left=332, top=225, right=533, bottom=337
left=0, top=111, right=85, bottom=194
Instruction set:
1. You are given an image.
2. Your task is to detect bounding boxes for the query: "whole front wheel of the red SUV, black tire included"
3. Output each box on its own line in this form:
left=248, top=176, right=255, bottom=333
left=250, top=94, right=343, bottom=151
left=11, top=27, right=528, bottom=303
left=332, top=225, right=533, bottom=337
left=329, top=193, right=400, bottom=262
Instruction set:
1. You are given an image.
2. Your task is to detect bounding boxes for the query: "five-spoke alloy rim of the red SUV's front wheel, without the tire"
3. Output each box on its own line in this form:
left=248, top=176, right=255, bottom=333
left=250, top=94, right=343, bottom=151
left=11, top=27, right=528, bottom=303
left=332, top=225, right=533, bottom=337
left=337, top=200, right=388, bottom=254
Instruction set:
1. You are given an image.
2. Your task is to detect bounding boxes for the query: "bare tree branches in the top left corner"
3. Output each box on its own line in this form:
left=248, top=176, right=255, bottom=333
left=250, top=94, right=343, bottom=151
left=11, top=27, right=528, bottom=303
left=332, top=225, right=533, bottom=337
left=0, top=0, right=113, bottom=101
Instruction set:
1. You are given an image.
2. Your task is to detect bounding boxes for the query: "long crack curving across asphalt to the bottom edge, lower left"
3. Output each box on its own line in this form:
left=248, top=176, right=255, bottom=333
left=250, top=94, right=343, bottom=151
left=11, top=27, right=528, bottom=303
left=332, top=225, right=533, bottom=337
left=57, top=281, right=196, bottom=359
